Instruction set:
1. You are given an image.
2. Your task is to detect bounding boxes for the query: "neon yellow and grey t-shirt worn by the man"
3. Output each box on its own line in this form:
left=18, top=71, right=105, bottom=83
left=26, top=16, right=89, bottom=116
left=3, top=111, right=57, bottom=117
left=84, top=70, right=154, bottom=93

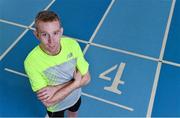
left=24, top=38, right=89, bottom=112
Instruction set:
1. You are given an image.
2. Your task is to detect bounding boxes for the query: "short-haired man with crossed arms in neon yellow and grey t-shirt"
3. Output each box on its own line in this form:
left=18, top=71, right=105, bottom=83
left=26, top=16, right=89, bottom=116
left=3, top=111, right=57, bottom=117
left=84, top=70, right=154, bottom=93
left=24, top=11, right=90, bottom=117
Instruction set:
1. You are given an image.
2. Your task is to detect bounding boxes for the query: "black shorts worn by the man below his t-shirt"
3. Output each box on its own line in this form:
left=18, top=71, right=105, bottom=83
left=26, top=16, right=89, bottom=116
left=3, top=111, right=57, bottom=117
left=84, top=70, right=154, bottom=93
left=47, top=98, right=81, bottom=117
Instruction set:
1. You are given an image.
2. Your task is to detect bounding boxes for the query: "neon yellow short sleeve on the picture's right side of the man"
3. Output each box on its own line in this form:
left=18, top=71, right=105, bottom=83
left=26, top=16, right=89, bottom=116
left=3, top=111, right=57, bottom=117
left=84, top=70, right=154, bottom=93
left=75, top=42, right=89, bottom=75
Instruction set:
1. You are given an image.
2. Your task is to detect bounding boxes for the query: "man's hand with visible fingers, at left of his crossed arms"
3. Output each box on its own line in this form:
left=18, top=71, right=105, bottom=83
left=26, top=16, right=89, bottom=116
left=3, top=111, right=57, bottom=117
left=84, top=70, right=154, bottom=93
left=37, top=86, right=56, bottom=102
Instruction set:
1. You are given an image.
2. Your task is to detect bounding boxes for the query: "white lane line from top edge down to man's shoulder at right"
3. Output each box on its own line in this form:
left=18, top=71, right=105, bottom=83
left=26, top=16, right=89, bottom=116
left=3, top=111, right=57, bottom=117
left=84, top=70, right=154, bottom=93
left=83, top=0, right=115, bottom=54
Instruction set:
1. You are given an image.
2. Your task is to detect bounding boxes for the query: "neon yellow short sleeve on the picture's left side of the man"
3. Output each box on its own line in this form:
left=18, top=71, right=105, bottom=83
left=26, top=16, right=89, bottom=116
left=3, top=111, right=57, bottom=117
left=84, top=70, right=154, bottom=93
left=24, top=61, right=48, bottom=92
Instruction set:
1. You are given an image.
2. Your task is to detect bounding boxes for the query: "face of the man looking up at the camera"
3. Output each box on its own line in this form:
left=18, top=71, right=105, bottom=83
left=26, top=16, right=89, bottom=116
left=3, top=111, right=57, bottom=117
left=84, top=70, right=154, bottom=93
left=35, top=21, right=63, bottom=55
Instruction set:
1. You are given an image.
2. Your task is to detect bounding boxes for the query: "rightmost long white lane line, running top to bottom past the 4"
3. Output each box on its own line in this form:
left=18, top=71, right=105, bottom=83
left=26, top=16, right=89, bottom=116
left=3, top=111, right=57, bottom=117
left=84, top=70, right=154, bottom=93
left=146, top=0, right=176, bottom=117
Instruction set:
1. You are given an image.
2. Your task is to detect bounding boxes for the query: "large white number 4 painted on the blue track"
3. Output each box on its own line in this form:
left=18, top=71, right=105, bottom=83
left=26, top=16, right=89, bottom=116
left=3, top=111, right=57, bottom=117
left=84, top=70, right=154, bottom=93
left=99, top=63, right=126, bottom=94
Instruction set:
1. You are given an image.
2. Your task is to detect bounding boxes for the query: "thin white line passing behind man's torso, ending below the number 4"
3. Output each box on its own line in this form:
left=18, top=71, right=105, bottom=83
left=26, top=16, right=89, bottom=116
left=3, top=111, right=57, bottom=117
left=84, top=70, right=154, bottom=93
left=4, top=68, right=134, bottom=111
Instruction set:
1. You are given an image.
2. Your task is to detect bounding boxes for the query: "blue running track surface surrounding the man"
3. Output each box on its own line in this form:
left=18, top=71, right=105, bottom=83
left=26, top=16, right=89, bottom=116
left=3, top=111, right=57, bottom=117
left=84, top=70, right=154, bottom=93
left=0, top=0, right=180, bottom=117
